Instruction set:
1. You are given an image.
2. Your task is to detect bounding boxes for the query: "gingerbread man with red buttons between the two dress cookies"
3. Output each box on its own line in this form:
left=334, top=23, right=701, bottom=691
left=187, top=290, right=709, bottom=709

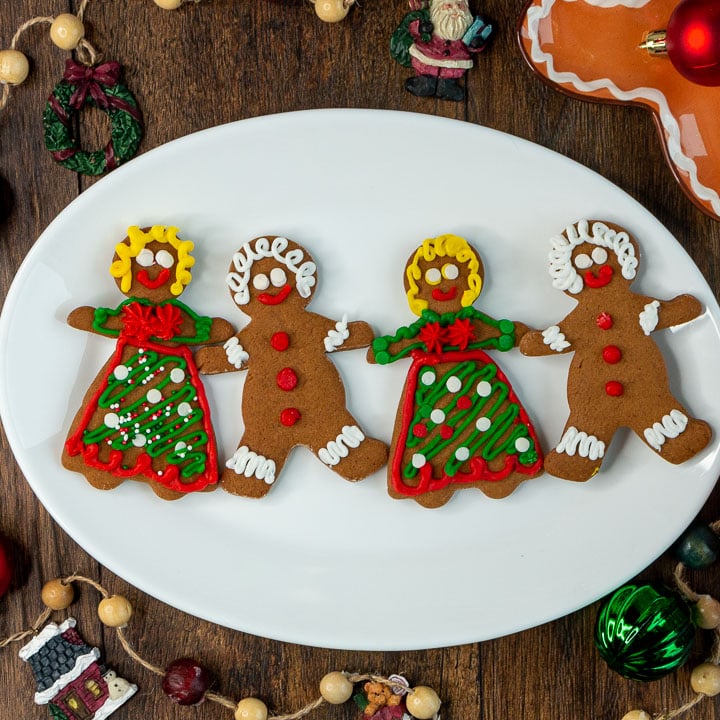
left=197, top=236, right=387, bottom=498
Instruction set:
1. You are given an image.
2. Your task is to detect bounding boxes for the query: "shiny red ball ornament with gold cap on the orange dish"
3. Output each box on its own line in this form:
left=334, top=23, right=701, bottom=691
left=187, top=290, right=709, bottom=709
left=643, top=0, right=720, bottom=86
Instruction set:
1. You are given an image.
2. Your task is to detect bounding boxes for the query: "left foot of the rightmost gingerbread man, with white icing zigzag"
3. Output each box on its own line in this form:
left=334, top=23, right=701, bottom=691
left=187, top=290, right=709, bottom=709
left=545, top=424, right=613, bottom=482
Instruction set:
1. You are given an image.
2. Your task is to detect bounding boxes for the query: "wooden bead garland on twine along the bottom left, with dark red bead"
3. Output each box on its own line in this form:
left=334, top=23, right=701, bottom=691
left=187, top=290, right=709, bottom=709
left=0, top=574, right=440, bottom=720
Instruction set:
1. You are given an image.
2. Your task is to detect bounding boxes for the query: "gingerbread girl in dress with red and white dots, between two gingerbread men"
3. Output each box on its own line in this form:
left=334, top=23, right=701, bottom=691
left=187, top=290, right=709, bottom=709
left=368, top=235, right=542, bottom=507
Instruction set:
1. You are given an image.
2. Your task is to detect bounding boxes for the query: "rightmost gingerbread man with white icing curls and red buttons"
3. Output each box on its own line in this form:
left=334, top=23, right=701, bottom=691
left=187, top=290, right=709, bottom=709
left=520, top=220, right=712, bottom=481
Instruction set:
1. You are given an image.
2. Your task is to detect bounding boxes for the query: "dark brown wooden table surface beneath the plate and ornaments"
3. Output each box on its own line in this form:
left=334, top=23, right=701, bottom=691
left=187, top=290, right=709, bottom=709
left=0, top=0, right=720, bottom=720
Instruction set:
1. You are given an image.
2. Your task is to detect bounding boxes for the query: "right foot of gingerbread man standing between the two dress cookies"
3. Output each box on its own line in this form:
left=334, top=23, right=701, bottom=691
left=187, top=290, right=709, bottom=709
left=312, top=424, right=388, bottom=482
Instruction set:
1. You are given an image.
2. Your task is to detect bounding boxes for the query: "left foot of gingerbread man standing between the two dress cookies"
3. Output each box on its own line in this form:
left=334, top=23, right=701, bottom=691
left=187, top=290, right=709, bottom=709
left=219, top=435, right=290, bottom=498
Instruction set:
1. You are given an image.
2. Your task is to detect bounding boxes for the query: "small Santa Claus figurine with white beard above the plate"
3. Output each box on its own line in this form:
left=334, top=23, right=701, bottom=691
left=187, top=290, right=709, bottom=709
left=390, top=0, right=493, bottom=102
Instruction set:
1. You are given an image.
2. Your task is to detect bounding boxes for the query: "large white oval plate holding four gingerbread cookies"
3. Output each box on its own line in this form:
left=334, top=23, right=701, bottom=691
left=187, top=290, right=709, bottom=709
left=0, top=110, right=720, bottom=649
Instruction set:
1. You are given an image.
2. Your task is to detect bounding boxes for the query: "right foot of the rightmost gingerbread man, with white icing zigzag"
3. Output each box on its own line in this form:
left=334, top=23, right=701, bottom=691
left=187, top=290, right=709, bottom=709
left=633, top=405, right=712, bottom=465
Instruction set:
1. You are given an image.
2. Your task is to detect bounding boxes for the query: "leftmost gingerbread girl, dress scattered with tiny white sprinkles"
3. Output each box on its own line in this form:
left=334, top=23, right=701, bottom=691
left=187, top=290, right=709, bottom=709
left=62, top=225, right=234, bottom=500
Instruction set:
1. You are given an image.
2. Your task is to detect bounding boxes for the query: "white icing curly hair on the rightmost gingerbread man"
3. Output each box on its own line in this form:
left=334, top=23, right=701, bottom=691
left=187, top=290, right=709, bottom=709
left=549, top=220, right=638, bottom=295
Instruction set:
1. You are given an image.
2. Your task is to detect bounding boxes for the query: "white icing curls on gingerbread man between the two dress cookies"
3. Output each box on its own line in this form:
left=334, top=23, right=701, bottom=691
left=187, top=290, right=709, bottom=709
left=225, top=237, right=317, bottom=305
